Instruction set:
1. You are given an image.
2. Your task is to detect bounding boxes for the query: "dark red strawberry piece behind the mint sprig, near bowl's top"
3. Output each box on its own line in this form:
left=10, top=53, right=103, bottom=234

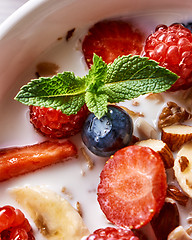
left=82, top=20, right=144, bottom=67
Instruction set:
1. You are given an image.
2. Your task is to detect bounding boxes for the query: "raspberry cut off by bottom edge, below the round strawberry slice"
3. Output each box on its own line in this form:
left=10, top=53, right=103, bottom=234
left=85, top=227, right=139, bottom=240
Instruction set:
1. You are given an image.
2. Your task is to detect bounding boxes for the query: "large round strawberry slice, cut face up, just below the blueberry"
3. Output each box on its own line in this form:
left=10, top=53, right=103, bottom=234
left=98, top=145, right=167, bottom=229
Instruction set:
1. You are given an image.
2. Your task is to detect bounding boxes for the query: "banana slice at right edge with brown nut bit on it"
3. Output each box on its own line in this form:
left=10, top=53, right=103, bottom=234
left=173, top=142, right=192, bottom=197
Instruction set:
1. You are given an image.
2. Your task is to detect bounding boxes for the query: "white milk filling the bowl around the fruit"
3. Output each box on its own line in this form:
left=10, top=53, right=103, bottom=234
left=0, top=11, right=192, bottom=240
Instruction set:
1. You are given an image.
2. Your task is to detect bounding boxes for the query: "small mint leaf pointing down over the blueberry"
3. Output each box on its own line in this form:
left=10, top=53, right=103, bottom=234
left=85, top=92, right=108, bottom=119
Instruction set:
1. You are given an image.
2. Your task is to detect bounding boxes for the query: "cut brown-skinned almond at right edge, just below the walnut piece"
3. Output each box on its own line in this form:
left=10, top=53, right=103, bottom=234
left=161, top=125, right=192, bottom=151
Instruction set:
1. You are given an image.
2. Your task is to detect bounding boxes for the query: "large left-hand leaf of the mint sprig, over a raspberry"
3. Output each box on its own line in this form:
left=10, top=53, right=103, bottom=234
left=15, top=72, right=86, bottom=115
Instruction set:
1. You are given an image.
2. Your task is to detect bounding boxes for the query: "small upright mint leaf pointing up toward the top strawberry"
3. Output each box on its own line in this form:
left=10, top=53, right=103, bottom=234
left=86, top=54, right=107, bottom=93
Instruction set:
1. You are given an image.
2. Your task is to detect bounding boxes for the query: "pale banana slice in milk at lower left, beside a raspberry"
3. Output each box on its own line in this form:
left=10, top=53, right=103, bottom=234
left=11, top=187, right=89, bottom=240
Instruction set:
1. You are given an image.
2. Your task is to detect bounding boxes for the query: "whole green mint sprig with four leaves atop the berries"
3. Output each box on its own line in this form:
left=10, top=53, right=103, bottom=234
left=15, top=54, right=178, bottom=118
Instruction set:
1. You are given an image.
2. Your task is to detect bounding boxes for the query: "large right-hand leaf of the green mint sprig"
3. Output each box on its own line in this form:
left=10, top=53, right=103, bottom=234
left=98, top=55, right=178, bottom=103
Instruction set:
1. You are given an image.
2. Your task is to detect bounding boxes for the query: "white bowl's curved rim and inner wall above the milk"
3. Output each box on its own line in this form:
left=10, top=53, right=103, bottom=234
left=0, top=0, right=192, bottom=98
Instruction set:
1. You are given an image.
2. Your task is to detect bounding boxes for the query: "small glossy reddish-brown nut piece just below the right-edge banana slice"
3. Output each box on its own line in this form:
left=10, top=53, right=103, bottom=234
left=167, top=185, right=189, bottom=206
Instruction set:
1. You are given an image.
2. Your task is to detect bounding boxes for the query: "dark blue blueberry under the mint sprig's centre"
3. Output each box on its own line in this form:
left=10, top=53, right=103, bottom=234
left=82, top=105, right=133, bottom=157
